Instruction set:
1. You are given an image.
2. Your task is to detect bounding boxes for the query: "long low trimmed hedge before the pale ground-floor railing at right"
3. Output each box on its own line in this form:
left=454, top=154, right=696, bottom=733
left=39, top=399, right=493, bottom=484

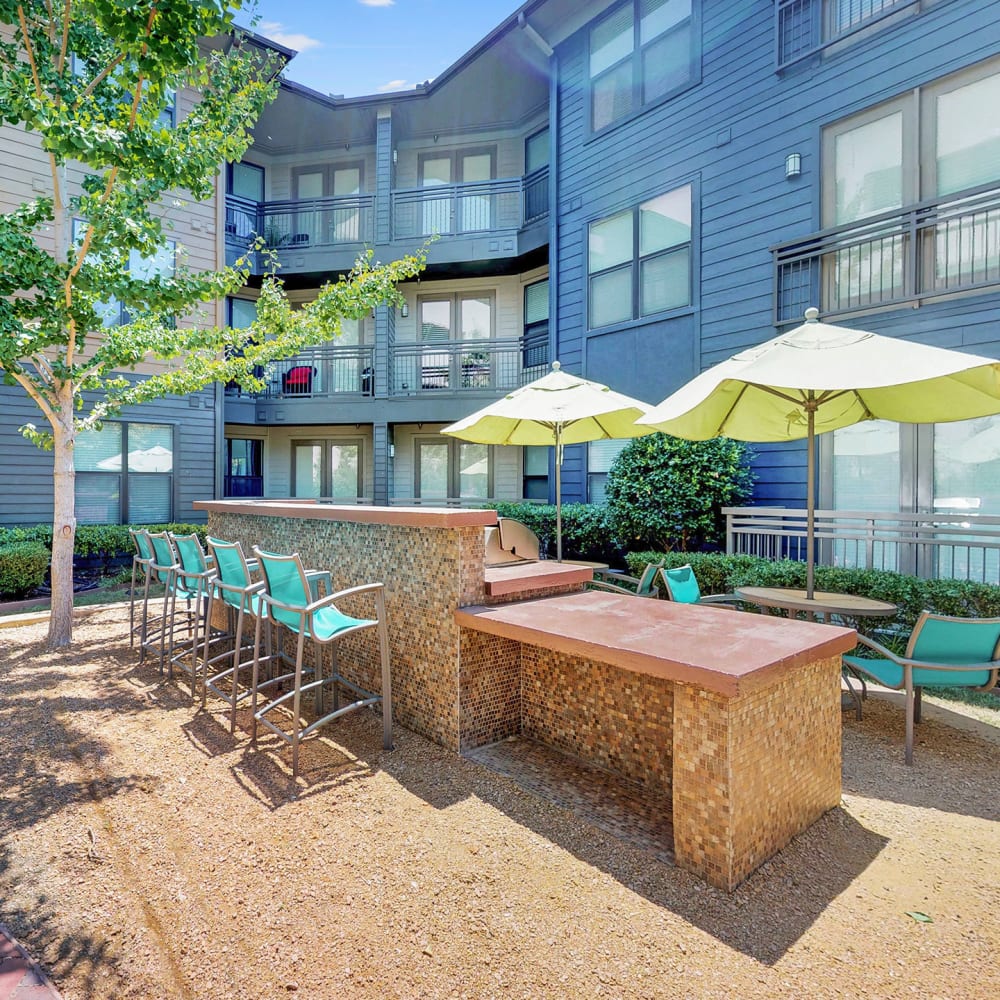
left=627, top=552, right=1000, bottom=633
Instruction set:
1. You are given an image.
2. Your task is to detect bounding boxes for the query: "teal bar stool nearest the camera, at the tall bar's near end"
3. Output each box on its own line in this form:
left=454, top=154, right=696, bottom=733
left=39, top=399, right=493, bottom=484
left=251, top=547, right=392, bottom=780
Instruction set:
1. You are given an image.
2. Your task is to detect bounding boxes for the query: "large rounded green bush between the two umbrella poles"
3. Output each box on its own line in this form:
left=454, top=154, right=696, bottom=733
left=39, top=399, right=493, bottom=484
left=607, top=434, right=754, bottom=552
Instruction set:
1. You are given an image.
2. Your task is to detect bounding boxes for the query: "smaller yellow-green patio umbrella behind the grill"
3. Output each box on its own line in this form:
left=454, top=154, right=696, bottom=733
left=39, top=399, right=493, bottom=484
left=441, top=361, right=654, bottom=562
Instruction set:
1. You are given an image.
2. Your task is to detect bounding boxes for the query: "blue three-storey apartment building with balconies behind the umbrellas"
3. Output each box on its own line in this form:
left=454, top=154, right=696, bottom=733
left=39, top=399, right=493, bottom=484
left=0, top=0, right=1000, bottom=519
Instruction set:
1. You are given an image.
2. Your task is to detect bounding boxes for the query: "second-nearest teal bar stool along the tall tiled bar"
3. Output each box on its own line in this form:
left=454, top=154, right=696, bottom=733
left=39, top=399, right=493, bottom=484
left=201, top=537, right=264, bottom=733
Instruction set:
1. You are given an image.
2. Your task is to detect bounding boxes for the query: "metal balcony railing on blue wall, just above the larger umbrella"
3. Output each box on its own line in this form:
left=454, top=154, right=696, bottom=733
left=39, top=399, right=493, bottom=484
left=772, top=184, right=1000, bottom=326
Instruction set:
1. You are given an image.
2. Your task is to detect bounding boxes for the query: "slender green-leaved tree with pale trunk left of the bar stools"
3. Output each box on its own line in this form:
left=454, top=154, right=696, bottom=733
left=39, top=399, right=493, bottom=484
left=0, top=0, right=423, bottom=646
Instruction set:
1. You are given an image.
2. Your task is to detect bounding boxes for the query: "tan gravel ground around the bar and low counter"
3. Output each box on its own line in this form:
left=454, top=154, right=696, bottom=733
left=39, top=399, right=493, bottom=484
left=0, top=605, right=1000, bottom=1000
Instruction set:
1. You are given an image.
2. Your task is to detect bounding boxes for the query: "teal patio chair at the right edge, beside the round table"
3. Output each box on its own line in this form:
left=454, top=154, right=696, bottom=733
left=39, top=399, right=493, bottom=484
left=844, top=611, right=1000, bottom=764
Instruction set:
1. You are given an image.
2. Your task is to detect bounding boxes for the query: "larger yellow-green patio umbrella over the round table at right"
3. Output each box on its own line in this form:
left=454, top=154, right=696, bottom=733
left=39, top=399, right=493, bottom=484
left=639, top=309, right=1000, bottom=598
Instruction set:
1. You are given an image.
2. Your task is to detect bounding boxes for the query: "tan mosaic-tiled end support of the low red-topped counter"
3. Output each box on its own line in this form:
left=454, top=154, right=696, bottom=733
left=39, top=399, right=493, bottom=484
left=673, top=657, right=840, bottom=891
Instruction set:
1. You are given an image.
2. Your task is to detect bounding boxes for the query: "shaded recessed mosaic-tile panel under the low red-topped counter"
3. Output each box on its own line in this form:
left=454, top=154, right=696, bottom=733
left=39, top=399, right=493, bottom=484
left=521, top=645, right=673, bottom=796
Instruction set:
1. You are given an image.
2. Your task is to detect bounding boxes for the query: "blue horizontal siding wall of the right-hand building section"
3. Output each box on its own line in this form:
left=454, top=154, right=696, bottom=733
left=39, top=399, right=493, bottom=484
left=552, top=0, right=1000, bottom=504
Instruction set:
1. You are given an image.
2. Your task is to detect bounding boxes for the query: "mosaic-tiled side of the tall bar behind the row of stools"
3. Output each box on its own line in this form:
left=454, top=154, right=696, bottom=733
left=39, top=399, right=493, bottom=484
left=209, top=511, right=485, bottom=751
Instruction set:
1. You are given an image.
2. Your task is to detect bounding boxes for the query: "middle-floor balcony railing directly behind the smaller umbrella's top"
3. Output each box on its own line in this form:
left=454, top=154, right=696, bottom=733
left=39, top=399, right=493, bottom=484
left=391, top=340, right=545, bottom=396
